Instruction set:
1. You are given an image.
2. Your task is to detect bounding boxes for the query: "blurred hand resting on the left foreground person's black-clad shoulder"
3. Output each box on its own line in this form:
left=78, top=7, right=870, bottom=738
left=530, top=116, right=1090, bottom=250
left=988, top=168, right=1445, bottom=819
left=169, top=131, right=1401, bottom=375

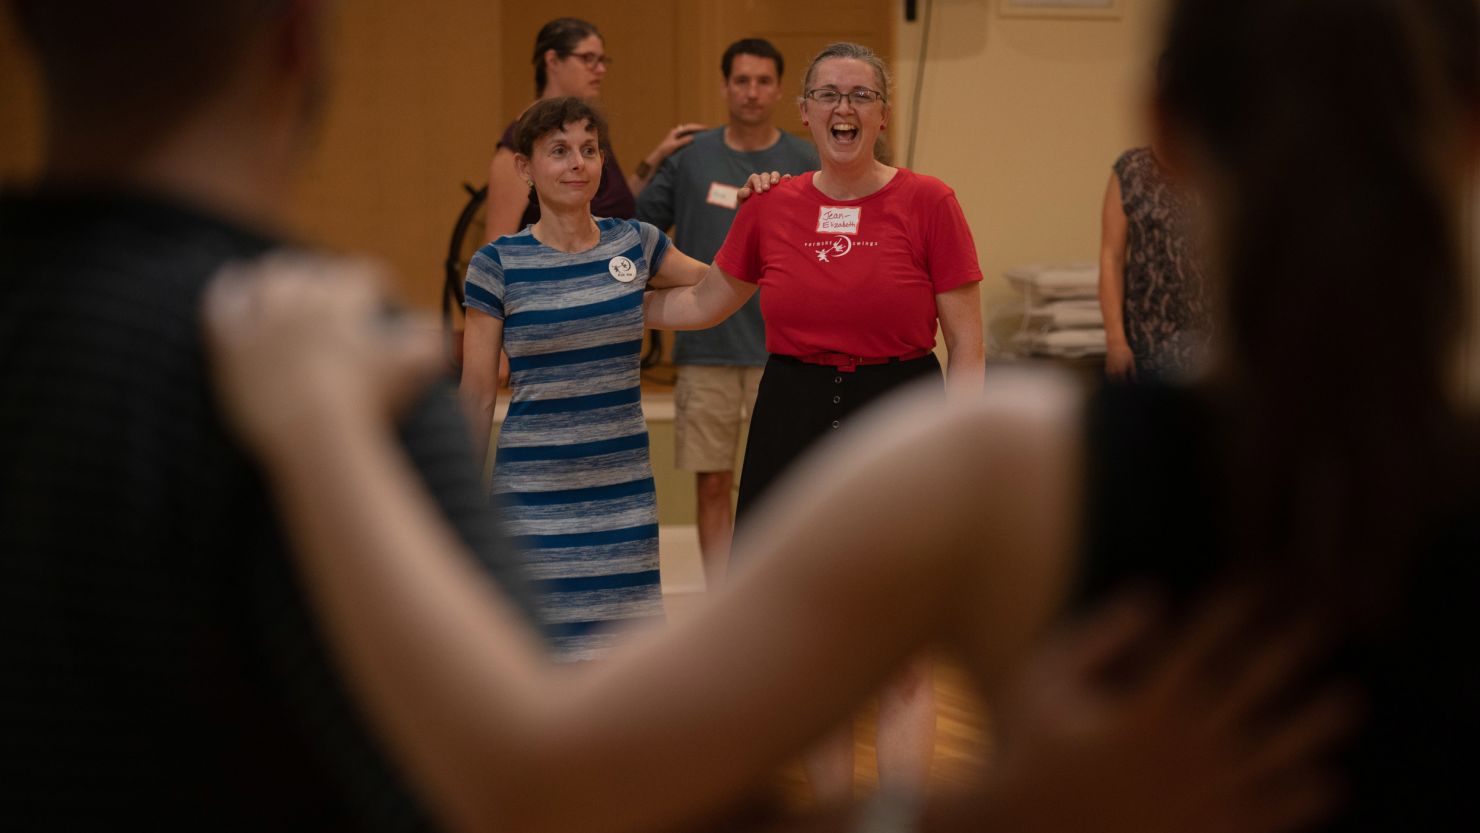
left=203, top=253, right=445, bottom=454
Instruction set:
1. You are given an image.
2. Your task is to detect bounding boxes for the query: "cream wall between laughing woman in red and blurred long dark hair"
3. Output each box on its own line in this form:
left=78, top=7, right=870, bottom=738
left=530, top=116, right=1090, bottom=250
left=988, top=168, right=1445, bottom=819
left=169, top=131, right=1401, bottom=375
left=889, top=0, right=1162, bottom=315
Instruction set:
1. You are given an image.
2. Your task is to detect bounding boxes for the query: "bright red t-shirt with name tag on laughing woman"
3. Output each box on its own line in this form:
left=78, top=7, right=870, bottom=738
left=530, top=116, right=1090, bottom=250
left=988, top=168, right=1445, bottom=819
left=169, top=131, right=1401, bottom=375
left=715, top=169, right=981, bottom=358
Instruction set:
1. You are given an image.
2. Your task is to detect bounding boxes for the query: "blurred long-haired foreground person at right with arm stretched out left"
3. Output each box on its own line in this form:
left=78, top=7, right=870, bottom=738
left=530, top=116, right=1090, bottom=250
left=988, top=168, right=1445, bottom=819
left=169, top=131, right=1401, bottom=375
left=199, top=0, right=1480, bottom=830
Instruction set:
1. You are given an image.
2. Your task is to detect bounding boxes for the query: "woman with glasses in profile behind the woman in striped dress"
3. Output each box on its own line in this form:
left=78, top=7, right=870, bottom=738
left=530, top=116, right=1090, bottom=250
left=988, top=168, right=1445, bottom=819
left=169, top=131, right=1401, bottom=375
left=484, top=18, right=704, bottom=241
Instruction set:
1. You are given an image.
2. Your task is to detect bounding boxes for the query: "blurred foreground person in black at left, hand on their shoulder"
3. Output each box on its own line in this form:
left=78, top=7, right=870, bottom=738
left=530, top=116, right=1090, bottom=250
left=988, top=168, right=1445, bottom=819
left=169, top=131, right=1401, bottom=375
left=0, top=0, right=529, bottom=832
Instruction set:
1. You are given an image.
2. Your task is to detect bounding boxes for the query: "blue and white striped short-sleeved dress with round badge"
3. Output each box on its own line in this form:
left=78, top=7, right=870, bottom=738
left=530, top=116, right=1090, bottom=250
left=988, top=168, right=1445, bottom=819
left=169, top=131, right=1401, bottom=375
left=465, top=219, right=669, bottom=660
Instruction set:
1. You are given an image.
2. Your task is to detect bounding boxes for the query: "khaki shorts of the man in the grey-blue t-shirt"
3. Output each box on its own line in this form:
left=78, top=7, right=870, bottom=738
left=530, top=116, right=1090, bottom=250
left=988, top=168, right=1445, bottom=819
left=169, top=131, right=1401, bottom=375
left=673, top=364, right=765, bottom=472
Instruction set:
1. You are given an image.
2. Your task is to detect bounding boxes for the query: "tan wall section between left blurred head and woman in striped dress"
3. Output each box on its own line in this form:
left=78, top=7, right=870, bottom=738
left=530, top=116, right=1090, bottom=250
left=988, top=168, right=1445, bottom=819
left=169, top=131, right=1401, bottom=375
left=295, top=0, right=503, bottom=308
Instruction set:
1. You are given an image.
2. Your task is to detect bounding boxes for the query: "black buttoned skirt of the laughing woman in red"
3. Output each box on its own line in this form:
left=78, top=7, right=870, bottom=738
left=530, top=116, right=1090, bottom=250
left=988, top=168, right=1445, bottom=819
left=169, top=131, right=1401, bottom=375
left=736, top=354, right=944, bottom=521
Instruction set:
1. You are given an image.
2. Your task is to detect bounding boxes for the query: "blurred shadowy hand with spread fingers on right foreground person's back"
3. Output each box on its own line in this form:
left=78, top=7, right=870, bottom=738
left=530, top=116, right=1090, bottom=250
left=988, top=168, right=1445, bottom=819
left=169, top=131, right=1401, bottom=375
left=993, top=591, right=1357, bottom=833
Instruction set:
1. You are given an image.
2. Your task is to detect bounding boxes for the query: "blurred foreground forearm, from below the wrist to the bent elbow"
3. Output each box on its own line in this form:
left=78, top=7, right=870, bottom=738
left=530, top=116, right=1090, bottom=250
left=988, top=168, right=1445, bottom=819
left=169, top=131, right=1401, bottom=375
left=257, top=414, right=549, bottom=830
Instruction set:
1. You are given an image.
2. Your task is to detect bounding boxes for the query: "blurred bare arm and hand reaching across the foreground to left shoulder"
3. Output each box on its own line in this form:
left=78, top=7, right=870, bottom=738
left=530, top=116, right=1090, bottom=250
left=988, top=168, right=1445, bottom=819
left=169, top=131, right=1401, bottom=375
left=212, top=260, right=1073, bottom=832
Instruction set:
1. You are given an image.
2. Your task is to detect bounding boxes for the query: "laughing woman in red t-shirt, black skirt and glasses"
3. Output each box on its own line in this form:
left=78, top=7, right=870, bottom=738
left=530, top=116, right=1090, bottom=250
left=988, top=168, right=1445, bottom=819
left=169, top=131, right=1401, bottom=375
left=647, top=43, right=984, bottom=800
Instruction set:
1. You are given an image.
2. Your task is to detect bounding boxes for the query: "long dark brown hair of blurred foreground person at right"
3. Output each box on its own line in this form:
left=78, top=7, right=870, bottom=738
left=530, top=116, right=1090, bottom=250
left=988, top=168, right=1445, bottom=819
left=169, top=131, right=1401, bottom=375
left=1159, top=0, right=1480, bottom=617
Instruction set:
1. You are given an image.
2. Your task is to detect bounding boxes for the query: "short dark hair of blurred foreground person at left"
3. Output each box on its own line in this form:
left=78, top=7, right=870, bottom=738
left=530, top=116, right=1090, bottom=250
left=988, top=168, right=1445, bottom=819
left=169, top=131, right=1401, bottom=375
left=10, top=0, right=283, bottom=152
